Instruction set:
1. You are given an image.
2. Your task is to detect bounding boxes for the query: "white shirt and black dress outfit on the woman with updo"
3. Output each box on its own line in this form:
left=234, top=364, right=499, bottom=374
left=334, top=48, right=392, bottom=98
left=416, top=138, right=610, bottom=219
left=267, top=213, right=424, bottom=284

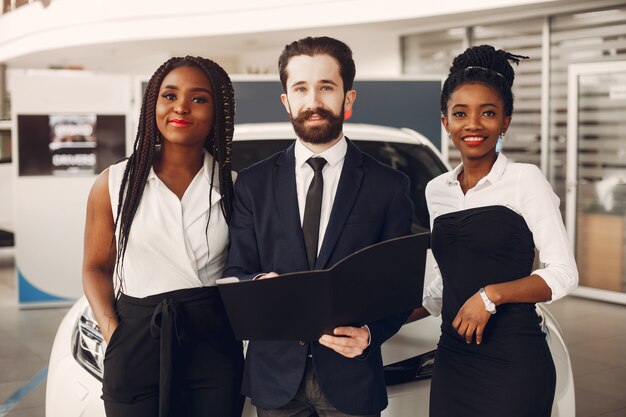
left=423, top=154, right=578, bottom=417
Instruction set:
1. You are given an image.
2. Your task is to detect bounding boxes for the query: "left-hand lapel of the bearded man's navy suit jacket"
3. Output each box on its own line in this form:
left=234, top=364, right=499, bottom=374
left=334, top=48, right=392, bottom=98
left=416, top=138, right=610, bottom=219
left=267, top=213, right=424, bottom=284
left=274, top=144, right=309, bottom=271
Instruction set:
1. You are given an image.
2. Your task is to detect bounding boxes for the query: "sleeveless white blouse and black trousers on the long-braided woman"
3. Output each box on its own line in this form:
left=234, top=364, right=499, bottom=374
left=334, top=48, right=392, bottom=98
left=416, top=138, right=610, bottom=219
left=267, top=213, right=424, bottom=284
left=102, top=153, right=243, bottom=417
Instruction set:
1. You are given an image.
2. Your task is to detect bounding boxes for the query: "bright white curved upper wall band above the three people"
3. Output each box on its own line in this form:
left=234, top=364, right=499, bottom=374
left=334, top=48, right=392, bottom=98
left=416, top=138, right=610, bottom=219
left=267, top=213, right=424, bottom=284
left=0, top=0, right=563, bottom=62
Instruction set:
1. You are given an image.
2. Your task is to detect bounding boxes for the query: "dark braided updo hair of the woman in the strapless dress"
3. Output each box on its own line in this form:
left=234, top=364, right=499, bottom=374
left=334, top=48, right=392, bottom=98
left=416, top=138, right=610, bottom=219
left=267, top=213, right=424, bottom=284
left=440, top=45, right=528, bottom=116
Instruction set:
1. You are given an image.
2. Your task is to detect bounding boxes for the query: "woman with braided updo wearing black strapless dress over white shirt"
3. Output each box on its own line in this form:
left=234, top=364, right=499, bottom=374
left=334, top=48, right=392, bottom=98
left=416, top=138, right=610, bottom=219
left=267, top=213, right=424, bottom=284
left=410, top=45, right=578, bottom=417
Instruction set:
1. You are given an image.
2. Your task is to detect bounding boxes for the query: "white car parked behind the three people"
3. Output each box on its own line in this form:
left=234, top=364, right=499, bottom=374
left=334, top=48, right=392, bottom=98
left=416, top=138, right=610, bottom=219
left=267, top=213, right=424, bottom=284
left=46, top=123, right=575, bottom=417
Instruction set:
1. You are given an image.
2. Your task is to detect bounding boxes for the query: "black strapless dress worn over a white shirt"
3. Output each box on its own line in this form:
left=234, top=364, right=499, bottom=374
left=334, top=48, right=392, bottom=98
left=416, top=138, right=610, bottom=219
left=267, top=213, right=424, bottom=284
left=430, top=206, right=556, bottom=417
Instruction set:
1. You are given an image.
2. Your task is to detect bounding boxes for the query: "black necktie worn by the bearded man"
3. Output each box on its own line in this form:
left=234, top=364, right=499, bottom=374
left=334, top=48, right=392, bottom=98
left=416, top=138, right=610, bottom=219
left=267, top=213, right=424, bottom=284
left=302, top=158, right=326, bottom=269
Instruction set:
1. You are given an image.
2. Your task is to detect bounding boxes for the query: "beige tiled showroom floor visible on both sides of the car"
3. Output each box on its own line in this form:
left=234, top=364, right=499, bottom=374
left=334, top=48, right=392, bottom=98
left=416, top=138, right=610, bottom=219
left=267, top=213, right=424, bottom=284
left=0, top=252, right=626, bottom=417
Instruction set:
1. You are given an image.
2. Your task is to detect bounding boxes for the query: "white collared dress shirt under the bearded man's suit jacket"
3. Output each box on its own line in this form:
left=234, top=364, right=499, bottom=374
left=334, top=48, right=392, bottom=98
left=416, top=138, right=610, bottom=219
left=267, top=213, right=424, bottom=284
left=294, top=135, right=348, bottom=253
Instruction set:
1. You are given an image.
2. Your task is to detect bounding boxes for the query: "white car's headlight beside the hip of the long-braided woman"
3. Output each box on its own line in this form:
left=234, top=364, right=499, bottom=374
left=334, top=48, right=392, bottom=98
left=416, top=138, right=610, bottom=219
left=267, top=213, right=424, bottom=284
left=72, top=306, right=106, bottom=381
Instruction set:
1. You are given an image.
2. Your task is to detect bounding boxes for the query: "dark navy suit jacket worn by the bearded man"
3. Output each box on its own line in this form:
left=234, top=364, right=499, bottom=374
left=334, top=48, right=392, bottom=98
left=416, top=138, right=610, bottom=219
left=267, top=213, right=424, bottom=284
left=224, top=141, right=412, bottom=414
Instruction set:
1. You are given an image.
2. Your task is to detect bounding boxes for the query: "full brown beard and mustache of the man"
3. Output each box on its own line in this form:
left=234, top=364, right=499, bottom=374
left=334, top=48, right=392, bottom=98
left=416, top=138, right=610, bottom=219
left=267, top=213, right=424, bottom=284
left=289, top=108, right=344, bottom=145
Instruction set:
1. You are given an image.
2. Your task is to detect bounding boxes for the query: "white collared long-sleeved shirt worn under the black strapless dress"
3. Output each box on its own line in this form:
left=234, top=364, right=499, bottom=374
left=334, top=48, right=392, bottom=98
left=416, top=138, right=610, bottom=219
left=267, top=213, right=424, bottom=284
left=423, top=153, right=578, bottom=316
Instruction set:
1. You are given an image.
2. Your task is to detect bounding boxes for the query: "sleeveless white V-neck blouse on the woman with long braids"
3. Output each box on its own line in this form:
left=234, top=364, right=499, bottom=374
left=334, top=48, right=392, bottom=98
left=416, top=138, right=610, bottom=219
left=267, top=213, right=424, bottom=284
left=109, top=153, right=229, bottom=298
